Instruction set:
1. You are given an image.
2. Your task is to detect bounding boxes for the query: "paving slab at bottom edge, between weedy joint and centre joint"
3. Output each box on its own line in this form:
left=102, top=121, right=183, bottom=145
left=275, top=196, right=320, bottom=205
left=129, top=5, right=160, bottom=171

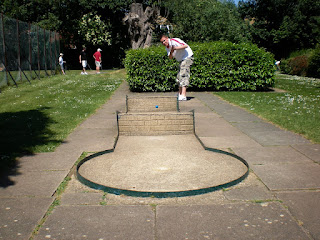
left=34, top=206, right=155, bottom=240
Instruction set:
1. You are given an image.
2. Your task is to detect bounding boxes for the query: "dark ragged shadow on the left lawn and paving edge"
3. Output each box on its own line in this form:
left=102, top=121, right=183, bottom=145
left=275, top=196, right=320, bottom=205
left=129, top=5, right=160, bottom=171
left=0, top=108, right=59, bottom=188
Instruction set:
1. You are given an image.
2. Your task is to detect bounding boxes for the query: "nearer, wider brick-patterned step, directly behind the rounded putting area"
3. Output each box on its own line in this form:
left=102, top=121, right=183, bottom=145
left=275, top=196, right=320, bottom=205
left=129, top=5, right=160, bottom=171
left=117, top=112, right=194, bottom=136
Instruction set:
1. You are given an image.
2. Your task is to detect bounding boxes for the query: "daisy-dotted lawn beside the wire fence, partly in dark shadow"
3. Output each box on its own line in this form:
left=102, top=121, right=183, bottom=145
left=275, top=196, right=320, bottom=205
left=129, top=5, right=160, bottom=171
left=0, top=69, right=126, bottom=171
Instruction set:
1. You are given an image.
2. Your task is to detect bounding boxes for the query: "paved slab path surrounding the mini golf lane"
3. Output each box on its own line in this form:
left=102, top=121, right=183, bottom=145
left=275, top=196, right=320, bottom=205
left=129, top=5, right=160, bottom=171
left=0, top=83, right=320, bottom=240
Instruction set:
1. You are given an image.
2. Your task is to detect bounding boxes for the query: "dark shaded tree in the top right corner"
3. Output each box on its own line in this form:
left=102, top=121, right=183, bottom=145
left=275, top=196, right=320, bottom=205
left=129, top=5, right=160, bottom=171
left=239, top=0, right=320, bottom=58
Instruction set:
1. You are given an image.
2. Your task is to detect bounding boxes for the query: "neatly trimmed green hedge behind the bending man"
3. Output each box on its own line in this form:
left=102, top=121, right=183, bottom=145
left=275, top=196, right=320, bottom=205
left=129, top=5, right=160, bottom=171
left=125, top=42, right=274, bottom=92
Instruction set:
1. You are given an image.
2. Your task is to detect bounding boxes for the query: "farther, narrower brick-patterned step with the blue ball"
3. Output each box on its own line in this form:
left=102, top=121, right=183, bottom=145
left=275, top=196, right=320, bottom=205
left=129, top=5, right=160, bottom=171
left=126, top=96, right=179, bottom=112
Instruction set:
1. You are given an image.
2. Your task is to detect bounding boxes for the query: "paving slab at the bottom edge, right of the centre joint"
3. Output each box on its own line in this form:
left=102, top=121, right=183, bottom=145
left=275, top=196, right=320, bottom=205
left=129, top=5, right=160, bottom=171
left=156, top=202, right=310, bottom=240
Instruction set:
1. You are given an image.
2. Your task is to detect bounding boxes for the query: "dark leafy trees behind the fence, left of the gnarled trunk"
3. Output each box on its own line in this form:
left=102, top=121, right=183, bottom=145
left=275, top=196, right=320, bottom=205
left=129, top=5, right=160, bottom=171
left=0, top=0, right=132, bottom=68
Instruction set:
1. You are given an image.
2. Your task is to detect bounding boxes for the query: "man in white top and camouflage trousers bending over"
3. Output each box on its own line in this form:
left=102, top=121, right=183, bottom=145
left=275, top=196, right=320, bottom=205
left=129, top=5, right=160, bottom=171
left=160, top=35, right=193, bottom=101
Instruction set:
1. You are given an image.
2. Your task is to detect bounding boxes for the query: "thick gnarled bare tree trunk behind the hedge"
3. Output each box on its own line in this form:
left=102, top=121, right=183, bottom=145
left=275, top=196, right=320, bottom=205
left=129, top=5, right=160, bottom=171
left=123, top=3, right=159, bottom=49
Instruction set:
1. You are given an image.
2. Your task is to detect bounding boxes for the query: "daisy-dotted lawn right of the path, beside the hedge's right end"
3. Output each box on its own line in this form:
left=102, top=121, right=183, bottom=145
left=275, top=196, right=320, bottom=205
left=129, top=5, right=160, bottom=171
left=215, top=74, right=320, bottom=143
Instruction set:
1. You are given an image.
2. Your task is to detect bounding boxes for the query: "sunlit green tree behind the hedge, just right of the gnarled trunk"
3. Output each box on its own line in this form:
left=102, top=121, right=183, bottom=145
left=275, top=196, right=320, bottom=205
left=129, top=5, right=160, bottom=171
left=164, top=0, right=250, bottom=42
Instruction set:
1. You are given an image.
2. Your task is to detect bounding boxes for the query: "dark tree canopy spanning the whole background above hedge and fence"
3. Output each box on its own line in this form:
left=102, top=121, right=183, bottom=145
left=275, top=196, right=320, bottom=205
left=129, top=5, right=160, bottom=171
left=0, top=0, right=320, bottom=64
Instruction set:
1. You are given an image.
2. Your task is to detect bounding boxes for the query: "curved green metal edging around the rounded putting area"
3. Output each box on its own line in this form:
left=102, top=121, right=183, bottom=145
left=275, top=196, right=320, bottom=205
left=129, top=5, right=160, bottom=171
left=76, top=134, right=249, bottom=198
